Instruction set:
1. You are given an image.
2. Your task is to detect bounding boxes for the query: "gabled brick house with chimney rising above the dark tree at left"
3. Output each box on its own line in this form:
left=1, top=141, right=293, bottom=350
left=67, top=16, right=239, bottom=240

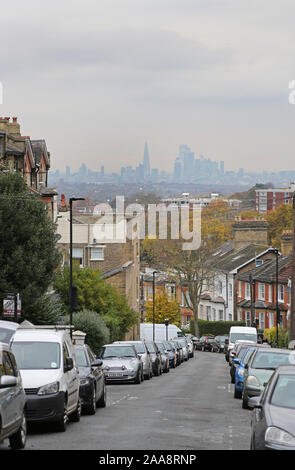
left=0, top=117, right=57, bottom=221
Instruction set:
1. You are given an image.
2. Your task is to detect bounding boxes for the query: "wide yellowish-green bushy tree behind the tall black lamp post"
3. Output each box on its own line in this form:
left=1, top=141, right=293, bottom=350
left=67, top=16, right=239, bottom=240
left=54, top=265, right=138, bottom=341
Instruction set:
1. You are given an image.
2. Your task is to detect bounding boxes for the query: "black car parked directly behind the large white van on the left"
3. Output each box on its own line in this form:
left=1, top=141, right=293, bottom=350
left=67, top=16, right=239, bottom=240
left=75, top=344, right=106, bottom=415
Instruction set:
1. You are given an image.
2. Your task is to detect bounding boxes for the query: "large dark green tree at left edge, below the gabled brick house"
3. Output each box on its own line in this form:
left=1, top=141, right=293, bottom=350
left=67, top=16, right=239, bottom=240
left=0, top=173, right=60, bottom=319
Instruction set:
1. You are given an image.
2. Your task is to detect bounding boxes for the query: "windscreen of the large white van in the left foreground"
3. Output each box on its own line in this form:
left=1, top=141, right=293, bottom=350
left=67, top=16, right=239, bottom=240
left=12, top=341, right=60, bottom=370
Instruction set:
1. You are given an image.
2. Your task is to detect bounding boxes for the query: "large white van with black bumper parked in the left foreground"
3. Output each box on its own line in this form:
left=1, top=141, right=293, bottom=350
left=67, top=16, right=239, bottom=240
left=11, top=328, right=81, bottom=432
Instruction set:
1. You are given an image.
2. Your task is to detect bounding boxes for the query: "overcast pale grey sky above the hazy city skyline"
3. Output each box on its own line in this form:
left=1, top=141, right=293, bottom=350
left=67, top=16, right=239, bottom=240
left=0, top=0, right=295, bottom=172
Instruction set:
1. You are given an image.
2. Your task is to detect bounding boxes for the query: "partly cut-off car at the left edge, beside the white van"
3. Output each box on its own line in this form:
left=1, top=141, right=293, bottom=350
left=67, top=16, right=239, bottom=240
left=0, top=343, right=27, bottom=450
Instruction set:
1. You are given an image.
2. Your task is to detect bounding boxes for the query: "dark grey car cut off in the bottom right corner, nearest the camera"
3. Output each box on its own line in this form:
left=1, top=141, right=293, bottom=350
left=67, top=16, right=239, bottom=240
left=249, top=365, right=295, bottom=450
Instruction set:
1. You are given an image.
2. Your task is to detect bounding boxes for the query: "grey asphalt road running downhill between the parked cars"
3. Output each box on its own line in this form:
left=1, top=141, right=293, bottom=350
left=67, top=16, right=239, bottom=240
left=0, top=351, right=251, bottom=450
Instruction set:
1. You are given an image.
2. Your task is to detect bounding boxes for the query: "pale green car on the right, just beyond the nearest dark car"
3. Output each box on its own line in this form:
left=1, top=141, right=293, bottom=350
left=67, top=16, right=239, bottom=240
left=242, top=346, right=294, bottom=409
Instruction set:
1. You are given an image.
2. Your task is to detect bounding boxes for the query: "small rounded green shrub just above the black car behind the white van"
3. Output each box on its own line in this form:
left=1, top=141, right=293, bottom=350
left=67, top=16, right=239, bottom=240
left=69, top=310, right=110, bottom=354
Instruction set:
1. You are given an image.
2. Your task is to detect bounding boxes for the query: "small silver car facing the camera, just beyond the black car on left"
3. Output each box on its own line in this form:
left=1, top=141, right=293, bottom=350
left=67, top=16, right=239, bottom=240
left=99, top=343, right=144, bottom=384
